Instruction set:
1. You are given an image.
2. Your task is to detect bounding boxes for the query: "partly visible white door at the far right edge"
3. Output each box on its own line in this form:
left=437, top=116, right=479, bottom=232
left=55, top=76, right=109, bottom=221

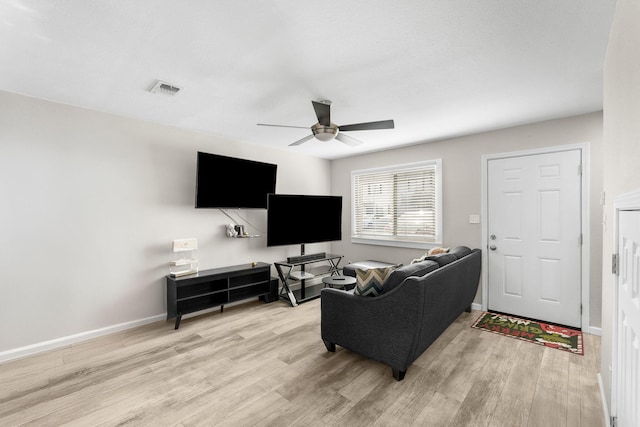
left=615, top=211, right=640, bottom=427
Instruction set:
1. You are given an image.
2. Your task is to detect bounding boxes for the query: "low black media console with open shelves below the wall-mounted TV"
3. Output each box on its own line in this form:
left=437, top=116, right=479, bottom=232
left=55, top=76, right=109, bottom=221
left=167, top=262, right=278, bottom=329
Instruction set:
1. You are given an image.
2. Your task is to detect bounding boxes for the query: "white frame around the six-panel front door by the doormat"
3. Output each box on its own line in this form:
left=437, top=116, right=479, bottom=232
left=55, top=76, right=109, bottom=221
left=481, top=143, right=599, bottom=335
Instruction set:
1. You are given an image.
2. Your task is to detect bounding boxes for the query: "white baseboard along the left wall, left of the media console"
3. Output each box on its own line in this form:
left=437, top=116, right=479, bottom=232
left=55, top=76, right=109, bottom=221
left=0, top=313, right=167, bottom=363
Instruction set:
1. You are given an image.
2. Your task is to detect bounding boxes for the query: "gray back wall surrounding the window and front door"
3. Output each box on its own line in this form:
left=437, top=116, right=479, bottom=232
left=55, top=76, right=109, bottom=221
left=331, top=113, right=602, bottom=327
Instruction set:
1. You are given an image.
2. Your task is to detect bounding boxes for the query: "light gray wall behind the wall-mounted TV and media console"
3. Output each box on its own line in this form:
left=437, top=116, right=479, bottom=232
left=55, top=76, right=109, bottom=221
left=0, top=92, right=330, bottom=360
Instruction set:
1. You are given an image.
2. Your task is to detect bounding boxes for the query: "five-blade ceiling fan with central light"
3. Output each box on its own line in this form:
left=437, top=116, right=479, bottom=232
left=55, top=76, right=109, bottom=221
left=258, top=101, right=394, bottom=147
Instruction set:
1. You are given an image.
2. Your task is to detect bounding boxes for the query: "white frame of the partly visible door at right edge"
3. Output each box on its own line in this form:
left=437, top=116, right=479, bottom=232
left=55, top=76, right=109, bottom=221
left=609, top=189, right=640, bottom=417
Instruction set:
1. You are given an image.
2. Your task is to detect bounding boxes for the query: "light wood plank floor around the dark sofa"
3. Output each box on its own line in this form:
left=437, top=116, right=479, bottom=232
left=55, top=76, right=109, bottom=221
left=0, top=300, right=604, bottom=427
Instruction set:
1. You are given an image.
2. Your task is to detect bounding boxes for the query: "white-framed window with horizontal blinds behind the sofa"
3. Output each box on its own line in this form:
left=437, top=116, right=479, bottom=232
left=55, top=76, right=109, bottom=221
left=351, top=159, right=442, bottom=248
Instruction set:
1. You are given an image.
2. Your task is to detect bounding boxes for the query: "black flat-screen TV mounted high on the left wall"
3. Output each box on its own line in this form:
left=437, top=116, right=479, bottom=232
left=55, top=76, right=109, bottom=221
left=196, top=151, right=277, bottom=209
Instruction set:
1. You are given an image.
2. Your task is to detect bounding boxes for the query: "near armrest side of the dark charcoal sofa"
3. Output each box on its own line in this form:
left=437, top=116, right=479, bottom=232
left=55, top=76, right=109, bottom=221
left=321, top=280, right=424, bottom=371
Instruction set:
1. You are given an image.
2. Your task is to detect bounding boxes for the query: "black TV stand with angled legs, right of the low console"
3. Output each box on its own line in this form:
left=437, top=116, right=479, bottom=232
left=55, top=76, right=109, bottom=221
left=273, top=254, right=342, bottom=307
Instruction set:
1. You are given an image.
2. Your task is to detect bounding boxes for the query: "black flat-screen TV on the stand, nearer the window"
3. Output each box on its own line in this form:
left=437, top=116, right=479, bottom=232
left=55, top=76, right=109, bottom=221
left=267, top=194, right=342, bottom=246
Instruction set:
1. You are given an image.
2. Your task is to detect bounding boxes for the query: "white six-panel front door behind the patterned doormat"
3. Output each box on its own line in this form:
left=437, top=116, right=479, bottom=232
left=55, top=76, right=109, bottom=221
left=487, top=149, right=582, bottom=327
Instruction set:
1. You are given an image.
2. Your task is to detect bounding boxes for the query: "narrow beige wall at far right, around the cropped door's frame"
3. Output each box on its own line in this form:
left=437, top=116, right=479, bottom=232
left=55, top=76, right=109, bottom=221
left=600, top=0, right=640, bottom=407
